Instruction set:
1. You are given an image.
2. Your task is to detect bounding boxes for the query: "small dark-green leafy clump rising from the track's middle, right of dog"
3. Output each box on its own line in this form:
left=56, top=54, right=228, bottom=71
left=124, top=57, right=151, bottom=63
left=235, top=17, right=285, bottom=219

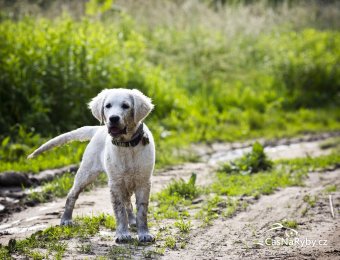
left=221, top=142, right=273, bottom=175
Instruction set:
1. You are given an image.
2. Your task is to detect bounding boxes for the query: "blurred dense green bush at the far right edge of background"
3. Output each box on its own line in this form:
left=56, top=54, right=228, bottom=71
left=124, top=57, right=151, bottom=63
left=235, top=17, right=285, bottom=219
left=261, top=29, right=340, bottom=108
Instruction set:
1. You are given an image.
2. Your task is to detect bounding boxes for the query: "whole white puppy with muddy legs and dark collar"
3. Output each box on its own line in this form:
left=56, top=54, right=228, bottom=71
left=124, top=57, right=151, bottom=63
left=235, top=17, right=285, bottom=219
left=28, top=89, right=155, bottom=242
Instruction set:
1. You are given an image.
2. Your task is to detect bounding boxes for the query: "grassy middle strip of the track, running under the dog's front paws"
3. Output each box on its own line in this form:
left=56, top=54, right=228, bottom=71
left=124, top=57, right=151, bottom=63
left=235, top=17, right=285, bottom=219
left=0, top=145, right=340, bottom=259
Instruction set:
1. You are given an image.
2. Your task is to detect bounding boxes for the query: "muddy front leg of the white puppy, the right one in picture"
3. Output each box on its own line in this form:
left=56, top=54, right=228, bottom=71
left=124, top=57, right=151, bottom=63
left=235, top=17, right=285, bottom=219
left=136, top=183, right=155, bottom=242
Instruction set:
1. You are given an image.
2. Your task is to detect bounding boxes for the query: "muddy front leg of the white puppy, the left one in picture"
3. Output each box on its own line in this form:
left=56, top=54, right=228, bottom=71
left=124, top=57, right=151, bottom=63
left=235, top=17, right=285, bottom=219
left=110, top=186, right=132, bottom=243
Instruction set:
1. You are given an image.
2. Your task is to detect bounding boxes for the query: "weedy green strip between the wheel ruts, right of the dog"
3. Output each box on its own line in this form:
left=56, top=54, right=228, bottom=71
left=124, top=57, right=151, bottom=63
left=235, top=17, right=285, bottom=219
left=151, top=144, right=340, bottom=224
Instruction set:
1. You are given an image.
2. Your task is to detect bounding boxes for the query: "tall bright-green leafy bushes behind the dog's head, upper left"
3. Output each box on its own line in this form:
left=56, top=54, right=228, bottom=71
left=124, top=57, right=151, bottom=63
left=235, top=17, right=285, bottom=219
left=0, top=16, right=180, bottom=135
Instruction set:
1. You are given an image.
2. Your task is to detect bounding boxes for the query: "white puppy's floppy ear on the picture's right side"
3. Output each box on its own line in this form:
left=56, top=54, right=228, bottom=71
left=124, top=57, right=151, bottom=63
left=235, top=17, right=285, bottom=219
left=131, top=89, right=154, bottom=123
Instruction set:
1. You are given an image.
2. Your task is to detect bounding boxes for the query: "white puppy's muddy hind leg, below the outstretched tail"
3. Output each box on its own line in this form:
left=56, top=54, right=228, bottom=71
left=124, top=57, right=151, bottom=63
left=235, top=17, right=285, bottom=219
left=60, top=163, right=100, bottom=225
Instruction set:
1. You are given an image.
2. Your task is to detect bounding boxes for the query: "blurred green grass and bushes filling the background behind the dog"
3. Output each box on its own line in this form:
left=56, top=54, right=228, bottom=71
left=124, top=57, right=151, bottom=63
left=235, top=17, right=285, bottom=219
left=0, top=1, right=340, bottom=172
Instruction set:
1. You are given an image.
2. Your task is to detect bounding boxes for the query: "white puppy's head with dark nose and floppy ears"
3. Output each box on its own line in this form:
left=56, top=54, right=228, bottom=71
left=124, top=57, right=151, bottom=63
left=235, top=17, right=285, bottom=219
left=89, top=88, right=154, bottom=138
